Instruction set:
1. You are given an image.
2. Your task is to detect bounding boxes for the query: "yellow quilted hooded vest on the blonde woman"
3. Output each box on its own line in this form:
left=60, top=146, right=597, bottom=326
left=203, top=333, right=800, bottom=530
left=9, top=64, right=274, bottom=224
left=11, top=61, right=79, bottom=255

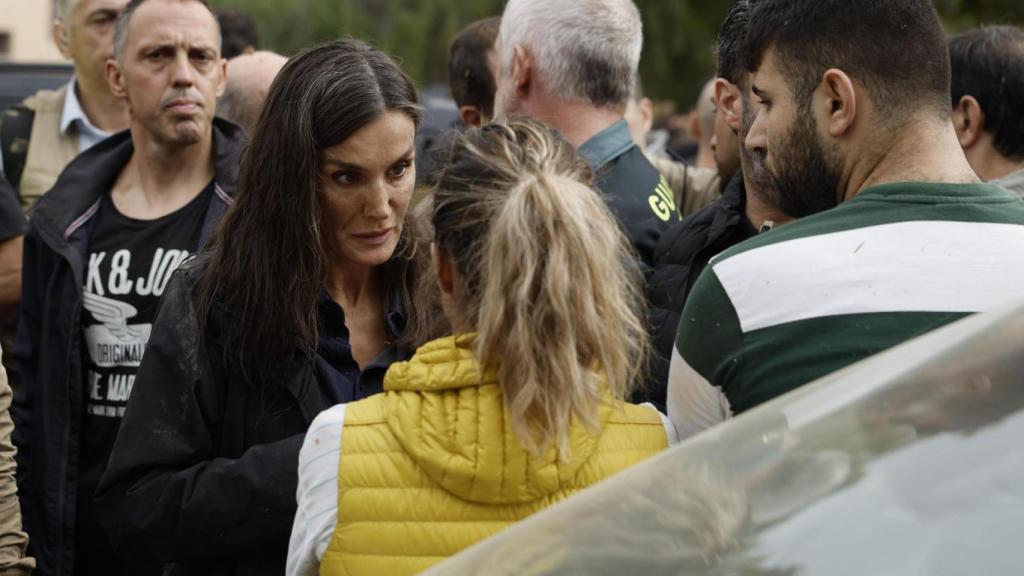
left=321, top=335, right=668, bottom=576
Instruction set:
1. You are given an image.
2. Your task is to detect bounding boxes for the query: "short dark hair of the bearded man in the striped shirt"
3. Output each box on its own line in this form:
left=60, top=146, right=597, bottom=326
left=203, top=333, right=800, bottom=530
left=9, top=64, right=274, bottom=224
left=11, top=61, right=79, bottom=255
left=743, top=0, right=950, bottom=118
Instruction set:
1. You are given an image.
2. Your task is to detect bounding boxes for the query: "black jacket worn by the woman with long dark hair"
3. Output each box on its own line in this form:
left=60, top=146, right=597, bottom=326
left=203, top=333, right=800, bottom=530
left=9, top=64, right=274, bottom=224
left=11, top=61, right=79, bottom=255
left=96, top=255, right=324, bottom=575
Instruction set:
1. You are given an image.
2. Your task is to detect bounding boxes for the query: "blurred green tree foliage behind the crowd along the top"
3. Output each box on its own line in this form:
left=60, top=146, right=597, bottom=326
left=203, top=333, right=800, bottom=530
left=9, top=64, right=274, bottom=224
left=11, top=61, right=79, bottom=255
left=212, top=0, right=1024, bottom=109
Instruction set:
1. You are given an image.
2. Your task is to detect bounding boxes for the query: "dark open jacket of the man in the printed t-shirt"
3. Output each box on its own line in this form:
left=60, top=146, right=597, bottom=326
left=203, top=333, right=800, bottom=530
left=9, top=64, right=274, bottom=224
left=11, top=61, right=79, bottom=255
left=11, top=120, right=245, bottom=576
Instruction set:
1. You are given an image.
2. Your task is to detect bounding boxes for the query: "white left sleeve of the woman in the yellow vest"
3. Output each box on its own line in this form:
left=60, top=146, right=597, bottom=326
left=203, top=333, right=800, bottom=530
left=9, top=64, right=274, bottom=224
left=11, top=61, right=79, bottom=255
left=286, top=404, right=345, bottom=576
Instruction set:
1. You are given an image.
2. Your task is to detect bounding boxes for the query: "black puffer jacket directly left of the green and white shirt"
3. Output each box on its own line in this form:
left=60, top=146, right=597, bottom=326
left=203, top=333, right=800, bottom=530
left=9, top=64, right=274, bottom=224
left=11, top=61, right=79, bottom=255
left=647, top=173, right=757, bottom=393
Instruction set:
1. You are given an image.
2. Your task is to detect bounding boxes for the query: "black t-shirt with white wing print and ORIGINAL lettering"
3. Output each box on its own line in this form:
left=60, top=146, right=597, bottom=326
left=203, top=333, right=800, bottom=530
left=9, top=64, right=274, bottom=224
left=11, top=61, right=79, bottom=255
left=76, top=182, right=214, bottom=574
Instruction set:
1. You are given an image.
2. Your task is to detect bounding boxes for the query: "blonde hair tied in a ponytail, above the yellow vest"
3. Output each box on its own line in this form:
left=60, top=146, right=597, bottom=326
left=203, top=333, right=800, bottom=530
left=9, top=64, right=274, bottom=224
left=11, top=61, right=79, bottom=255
left=434, top=119, right=647, bottom=458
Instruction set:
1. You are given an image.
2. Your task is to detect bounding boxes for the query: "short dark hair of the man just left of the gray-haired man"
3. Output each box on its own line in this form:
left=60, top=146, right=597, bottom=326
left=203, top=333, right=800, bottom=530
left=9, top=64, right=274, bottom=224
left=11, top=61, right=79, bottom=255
left=449, top=16, right=502, bottom=116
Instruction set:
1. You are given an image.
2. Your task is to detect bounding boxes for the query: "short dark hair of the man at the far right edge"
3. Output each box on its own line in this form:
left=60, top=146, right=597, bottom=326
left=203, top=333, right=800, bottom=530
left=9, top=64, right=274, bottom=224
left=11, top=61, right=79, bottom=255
left=949, top=26, right=1024, bottom=160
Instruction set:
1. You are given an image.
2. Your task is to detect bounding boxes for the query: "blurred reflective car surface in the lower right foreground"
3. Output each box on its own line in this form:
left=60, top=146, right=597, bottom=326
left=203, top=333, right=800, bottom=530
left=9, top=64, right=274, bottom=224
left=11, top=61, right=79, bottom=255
left=427, top=297, right=1024, bottom=576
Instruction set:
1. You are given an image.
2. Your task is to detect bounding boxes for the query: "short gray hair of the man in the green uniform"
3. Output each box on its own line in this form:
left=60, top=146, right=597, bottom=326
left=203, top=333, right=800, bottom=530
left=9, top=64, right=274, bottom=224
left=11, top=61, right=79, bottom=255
left=499, top=0, right=643, bottom=107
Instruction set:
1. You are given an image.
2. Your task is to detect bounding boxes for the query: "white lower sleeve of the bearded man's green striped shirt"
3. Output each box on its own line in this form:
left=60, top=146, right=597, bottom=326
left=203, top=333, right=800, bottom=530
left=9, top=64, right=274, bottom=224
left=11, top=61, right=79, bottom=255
left=666, top=346, right=732, bottom=441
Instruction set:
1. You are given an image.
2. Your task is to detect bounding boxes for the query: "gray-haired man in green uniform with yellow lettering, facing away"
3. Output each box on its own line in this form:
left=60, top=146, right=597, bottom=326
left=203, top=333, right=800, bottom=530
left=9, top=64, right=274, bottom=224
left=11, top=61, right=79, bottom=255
left=495, top=0, right=679, bottom=266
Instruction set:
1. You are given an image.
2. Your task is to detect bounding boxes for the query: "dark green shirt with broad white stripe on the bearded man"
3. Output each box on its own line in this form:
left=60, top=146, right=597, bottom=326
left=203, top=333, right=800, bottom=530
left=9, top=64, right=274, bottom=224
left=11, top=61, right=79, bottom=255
left=668, top=182, right=1024, bottom=438
